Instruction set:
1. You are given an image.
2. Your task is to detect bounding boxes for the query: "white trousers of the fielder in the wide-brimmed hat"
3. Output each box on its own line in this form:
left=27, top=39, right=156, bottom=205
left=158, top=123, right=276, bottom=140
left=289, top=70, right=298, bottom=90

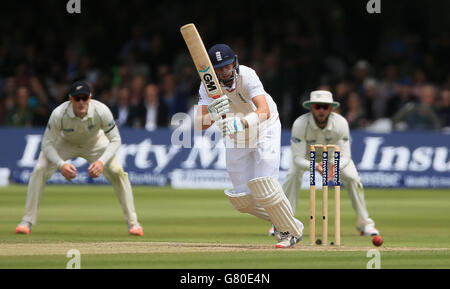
left=282, top=161, right=375, bottom=231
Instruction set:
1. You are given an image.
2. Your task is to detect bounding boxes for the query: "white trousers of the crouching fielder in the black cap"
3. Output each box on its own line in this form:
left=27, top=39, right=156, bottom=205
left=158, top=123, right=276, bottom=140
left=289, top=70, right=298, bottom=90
left=22, top=136, right=138, bottom=226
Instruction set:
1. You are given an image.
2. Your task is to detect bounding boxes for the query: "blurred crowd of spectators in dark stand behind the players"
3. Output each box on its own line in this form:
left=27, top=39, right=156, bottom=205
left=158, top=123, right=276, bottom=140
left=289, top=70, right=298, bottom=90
left=0, top=0, right=450, bottom=131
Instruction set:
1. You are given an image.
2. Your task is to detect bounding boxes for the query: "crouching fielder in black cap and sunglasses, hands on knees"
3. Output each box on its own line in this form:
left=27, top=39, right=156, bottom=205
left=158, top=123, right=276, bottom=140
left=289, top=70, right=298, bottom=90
left=16, top=81, right=144, bottom=236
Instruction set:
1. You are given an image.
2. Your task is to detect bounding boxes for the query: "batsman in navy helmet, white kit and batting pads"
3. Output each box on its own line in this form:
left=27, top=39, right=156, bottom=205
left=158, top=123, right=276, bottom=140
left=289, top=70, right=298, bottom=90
left=196, top=44, right=303, bottom=248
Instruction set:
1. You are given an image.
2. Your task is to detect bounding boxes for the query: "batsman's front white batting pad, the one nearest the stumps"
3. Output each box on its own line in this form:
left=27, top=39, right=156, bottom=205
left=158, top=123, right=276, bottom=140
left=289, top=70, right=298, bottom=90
left=248, top=177, right=302, bottom=237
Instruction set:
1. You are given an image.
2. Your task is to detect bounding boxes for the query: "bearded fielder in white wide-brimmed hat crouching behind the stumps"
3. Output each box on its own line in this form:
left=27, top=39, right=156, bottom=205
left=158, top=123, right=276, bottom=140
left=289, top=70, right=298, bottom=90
left=278, top=90, right=379, bottom=236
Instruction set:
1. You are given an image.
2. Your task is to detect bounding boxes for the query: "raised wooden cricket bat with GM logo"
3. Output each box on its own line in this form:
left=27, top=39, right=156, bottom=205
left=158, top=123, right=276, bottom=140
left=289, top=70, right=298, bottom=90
left=180, top=23, right=222, bottom=99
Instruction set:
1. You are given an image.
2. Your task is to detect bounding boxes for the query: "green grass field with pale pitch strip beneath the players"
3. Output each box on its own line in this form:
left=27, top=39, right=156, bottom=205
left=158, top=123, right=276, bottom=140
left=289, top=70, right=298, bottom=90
left=0, top=185, right=450, bottom=269
